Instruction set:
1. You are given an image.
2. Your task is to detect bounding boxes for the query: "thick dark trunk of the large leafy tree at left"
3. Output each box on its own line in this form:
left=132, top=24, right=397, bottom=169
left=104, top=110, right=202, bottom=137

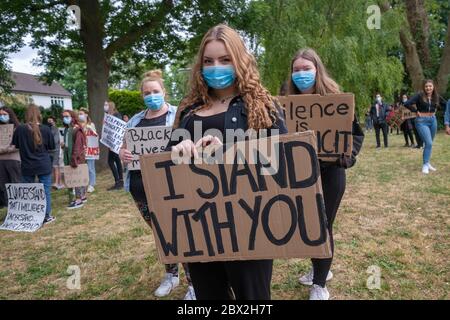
left=78, top=0, right=109, bottom=169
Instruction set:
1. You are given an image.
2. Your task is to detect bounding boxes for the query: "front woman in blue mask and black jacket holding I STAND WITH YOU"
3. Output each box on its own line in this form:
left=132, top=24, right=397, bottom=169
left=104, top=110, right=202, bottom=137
left=169, top=25, right=287, bottom=300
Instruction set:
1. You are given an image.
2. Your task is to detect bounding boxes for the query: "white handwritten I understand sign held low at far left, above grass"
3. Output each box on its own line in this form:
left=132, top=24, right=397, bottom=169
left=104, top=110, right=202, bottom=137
left=0, top=183, right=47, bottom=232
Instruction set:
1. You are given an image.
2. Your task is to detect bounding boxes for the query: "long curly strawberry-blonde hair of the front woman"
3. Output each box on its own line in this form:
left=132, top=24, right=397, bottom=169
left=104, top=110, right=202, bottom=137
left=174, top=24, right=278, bottom=130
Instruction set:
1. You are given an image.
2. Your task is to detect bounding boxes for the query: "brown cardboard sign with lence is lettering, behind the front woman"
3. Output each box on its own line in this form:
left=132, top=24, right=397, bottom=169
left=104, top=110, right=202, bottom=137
left=277, top=93, right=355, bottom=161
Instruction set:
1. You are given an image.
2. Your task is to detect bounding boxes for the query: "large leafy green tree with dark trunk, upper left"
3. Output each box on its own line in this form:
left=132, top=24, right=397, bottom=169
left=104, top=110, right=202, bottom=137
left=0, top=0, right=245, bottom=168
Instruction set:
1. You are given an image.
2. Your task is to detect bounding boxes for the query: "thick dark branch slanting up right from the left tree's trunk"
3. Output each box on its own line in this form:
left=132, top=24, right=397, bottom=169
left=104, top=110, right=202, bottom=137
left=105, top=0, right=173, bottom=60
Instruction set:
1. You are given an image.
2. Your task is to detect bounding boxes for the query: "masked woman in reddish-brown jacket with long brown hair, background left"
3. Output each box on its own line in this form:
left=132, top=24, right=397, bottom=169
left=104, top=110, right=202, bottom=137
left=62, top=110, right=87, bottom=210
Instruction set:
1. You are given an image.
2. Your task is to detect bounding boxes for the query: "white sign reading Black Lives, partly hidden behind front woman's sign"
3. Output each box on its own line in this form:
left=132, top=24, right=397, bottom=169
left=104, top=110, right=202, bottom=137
left=125, top=126, right=172, bottom=170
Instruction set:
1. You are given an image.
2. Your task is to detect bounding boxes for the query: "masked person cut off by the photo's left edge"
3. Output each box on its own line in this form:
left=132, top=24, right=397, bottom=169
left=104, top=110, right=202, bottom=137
left=0, top=107, right=21, bottom=208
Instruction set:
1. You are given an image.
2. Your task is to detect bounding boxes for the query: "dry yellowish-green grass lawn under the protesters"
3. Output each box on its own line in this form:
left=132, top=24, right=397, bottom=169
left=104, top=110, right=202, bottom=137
left=0, top=132, right=450, bottom=299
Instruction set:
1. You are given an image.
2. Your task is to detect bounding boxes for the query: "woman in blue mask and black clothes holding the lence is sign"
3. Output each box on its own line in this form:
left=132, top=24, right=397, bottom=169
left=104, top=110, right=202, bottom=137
left=288, top=49, right=364, bottom=300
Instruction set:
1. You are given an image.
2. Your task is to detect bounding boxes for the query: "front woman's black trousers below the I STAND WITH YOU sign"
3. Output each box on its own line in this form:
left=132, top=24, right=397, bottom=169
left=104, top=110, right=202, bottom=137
left=189, top=260, right=273, bottom=300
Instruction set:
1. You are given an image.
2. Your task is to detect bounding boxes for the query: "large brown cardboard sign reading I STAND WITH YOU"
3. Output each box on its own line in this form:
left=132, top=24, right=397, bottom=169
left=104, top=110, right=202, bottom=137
left=140, top=131, right=331, bottom=263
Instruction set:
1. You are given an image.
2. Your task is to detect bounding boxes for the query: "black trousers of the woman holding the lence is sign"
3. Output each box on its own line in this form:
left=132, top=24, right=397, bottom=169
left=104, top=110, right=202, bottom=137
left=311, top=166, right=346, bottom=287
